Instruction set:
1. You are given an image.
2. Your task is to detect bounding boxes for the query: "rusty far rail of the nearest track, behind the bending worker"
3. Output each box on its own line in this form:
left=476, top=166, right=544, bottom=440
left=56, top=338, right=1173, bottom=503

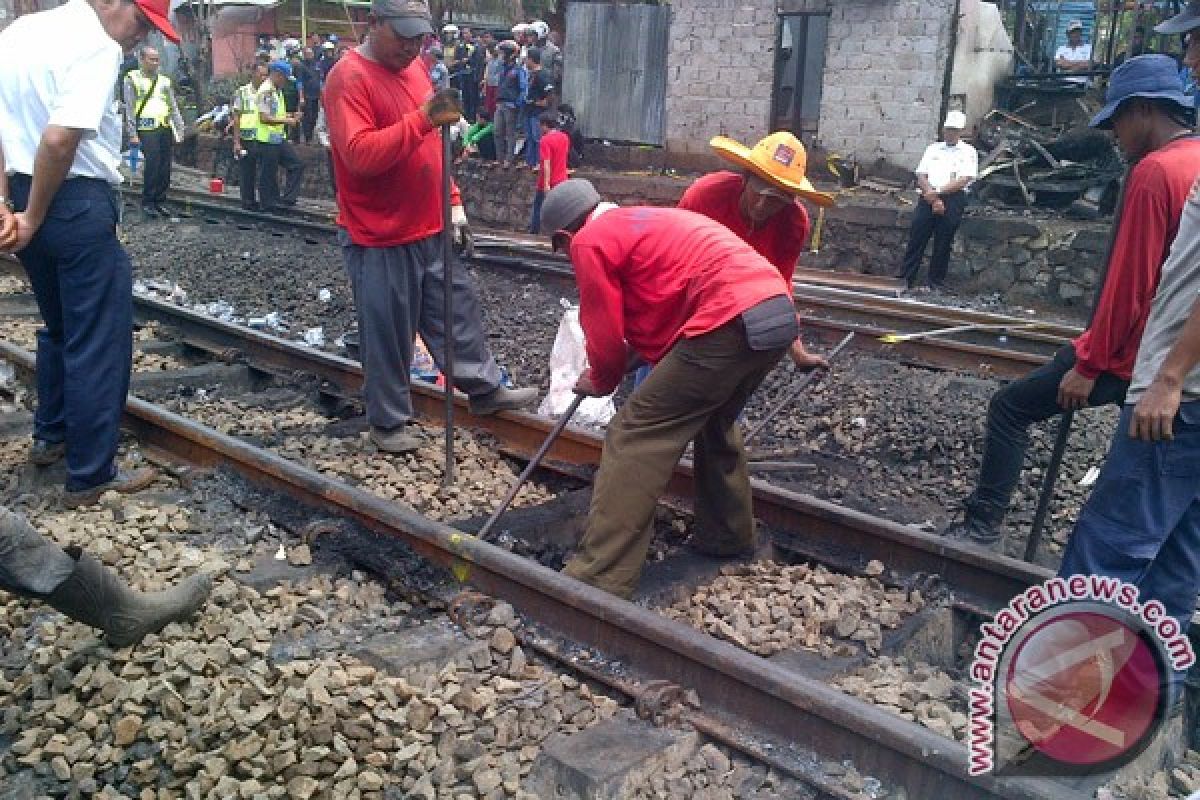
left=124, top=296, right=1050, bottom=609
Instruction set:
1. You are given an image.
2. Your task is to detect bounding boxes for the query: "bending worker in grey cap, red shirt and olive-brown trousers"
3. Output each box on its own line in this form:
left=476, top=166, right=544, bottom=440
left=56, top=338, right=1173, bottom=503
left=542, top=179, right=830, bottom=597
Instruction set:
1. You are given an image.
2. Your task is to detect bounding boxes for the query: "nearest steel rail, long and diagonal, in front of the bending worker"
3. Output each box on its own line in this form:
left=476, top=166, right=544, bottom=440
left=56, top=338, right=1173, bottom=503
left=0, top=342, right=1082, bottom=800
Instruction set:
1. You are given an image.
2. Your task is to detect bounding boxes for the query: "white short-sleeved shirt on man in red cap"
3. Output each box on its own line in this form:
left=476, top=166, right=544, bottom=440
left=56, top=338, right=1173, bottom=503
left=0, top=0, right=121, bottom=184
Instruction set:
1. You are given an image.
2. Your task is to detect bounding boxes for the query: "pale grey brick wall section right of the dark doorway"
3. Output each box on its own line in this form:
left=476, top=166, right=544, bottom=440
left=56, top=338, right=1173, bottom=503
left=817, top=0, right=955, bottom=169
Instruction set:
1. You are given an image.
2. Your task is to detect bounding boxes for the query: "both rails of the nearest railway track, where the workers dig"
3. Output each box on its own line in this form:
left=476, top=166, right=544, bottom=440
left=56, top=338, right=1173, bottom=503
left=0, top=253, right=1099, bottom=799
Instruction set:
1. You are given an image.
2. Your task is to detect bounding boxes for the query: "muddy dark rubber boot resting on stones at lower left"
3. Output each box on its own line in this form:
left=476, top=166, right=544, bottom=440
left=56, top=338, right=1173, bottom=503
left=46, top=547, right=212, bottom=648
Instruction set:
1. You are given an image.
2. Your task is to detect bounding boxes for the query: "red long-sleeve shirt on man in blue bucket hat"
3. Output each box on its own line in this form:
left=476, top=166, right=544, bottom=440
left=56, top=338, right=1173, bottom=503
left=1075, top=138, right=1200, bottom=380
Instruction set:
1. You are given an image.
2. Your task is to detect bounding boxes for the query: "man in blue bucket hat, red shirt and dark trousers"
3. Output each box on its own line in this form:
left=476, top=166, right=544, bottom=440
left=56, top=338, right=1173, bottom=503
left=944, top=55, right=1200, bottom=545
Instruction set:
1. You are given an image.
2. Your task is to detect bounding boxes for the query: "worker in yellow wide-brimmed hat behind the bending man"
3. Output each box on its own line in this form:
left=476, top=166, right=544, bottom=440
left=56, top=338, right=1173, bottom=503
left=679, top=131, right=834, bottom=368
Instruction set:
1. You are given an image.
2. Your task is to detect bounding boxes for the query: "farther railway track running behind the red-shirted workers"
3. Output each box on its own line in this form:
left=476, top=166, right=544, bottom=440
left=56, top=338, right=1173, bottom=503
left=138, top=183, right=1080, bottom=378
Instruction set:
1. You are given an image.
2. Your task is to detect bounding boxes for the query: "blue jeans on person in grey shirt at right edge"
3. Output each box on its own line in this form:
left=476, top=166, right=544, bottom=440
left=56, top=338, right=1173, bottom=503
left=1058, top=401, right=1200, bottom=632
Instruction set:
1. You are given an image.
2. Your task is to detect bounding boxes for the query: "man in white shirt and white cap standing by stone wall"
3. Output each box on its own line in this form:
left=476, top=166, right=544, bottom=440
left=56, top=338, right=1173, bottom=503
left=900, top=112, right=979, bottom=290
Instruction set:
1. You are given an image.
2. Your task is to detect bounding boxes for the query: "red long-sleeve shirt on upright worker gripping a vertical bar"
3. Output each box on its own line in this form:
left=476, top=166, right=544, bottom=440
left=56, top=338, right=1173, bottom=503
left=322, top=50, right=462, bottom=247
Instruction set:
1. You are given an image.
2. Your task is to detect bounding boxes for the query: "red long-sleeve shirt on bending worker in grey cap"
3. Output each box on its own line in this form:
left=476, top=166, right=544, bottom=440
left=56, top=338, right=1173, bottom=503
left=570, top=206, right=791, bottom=392
